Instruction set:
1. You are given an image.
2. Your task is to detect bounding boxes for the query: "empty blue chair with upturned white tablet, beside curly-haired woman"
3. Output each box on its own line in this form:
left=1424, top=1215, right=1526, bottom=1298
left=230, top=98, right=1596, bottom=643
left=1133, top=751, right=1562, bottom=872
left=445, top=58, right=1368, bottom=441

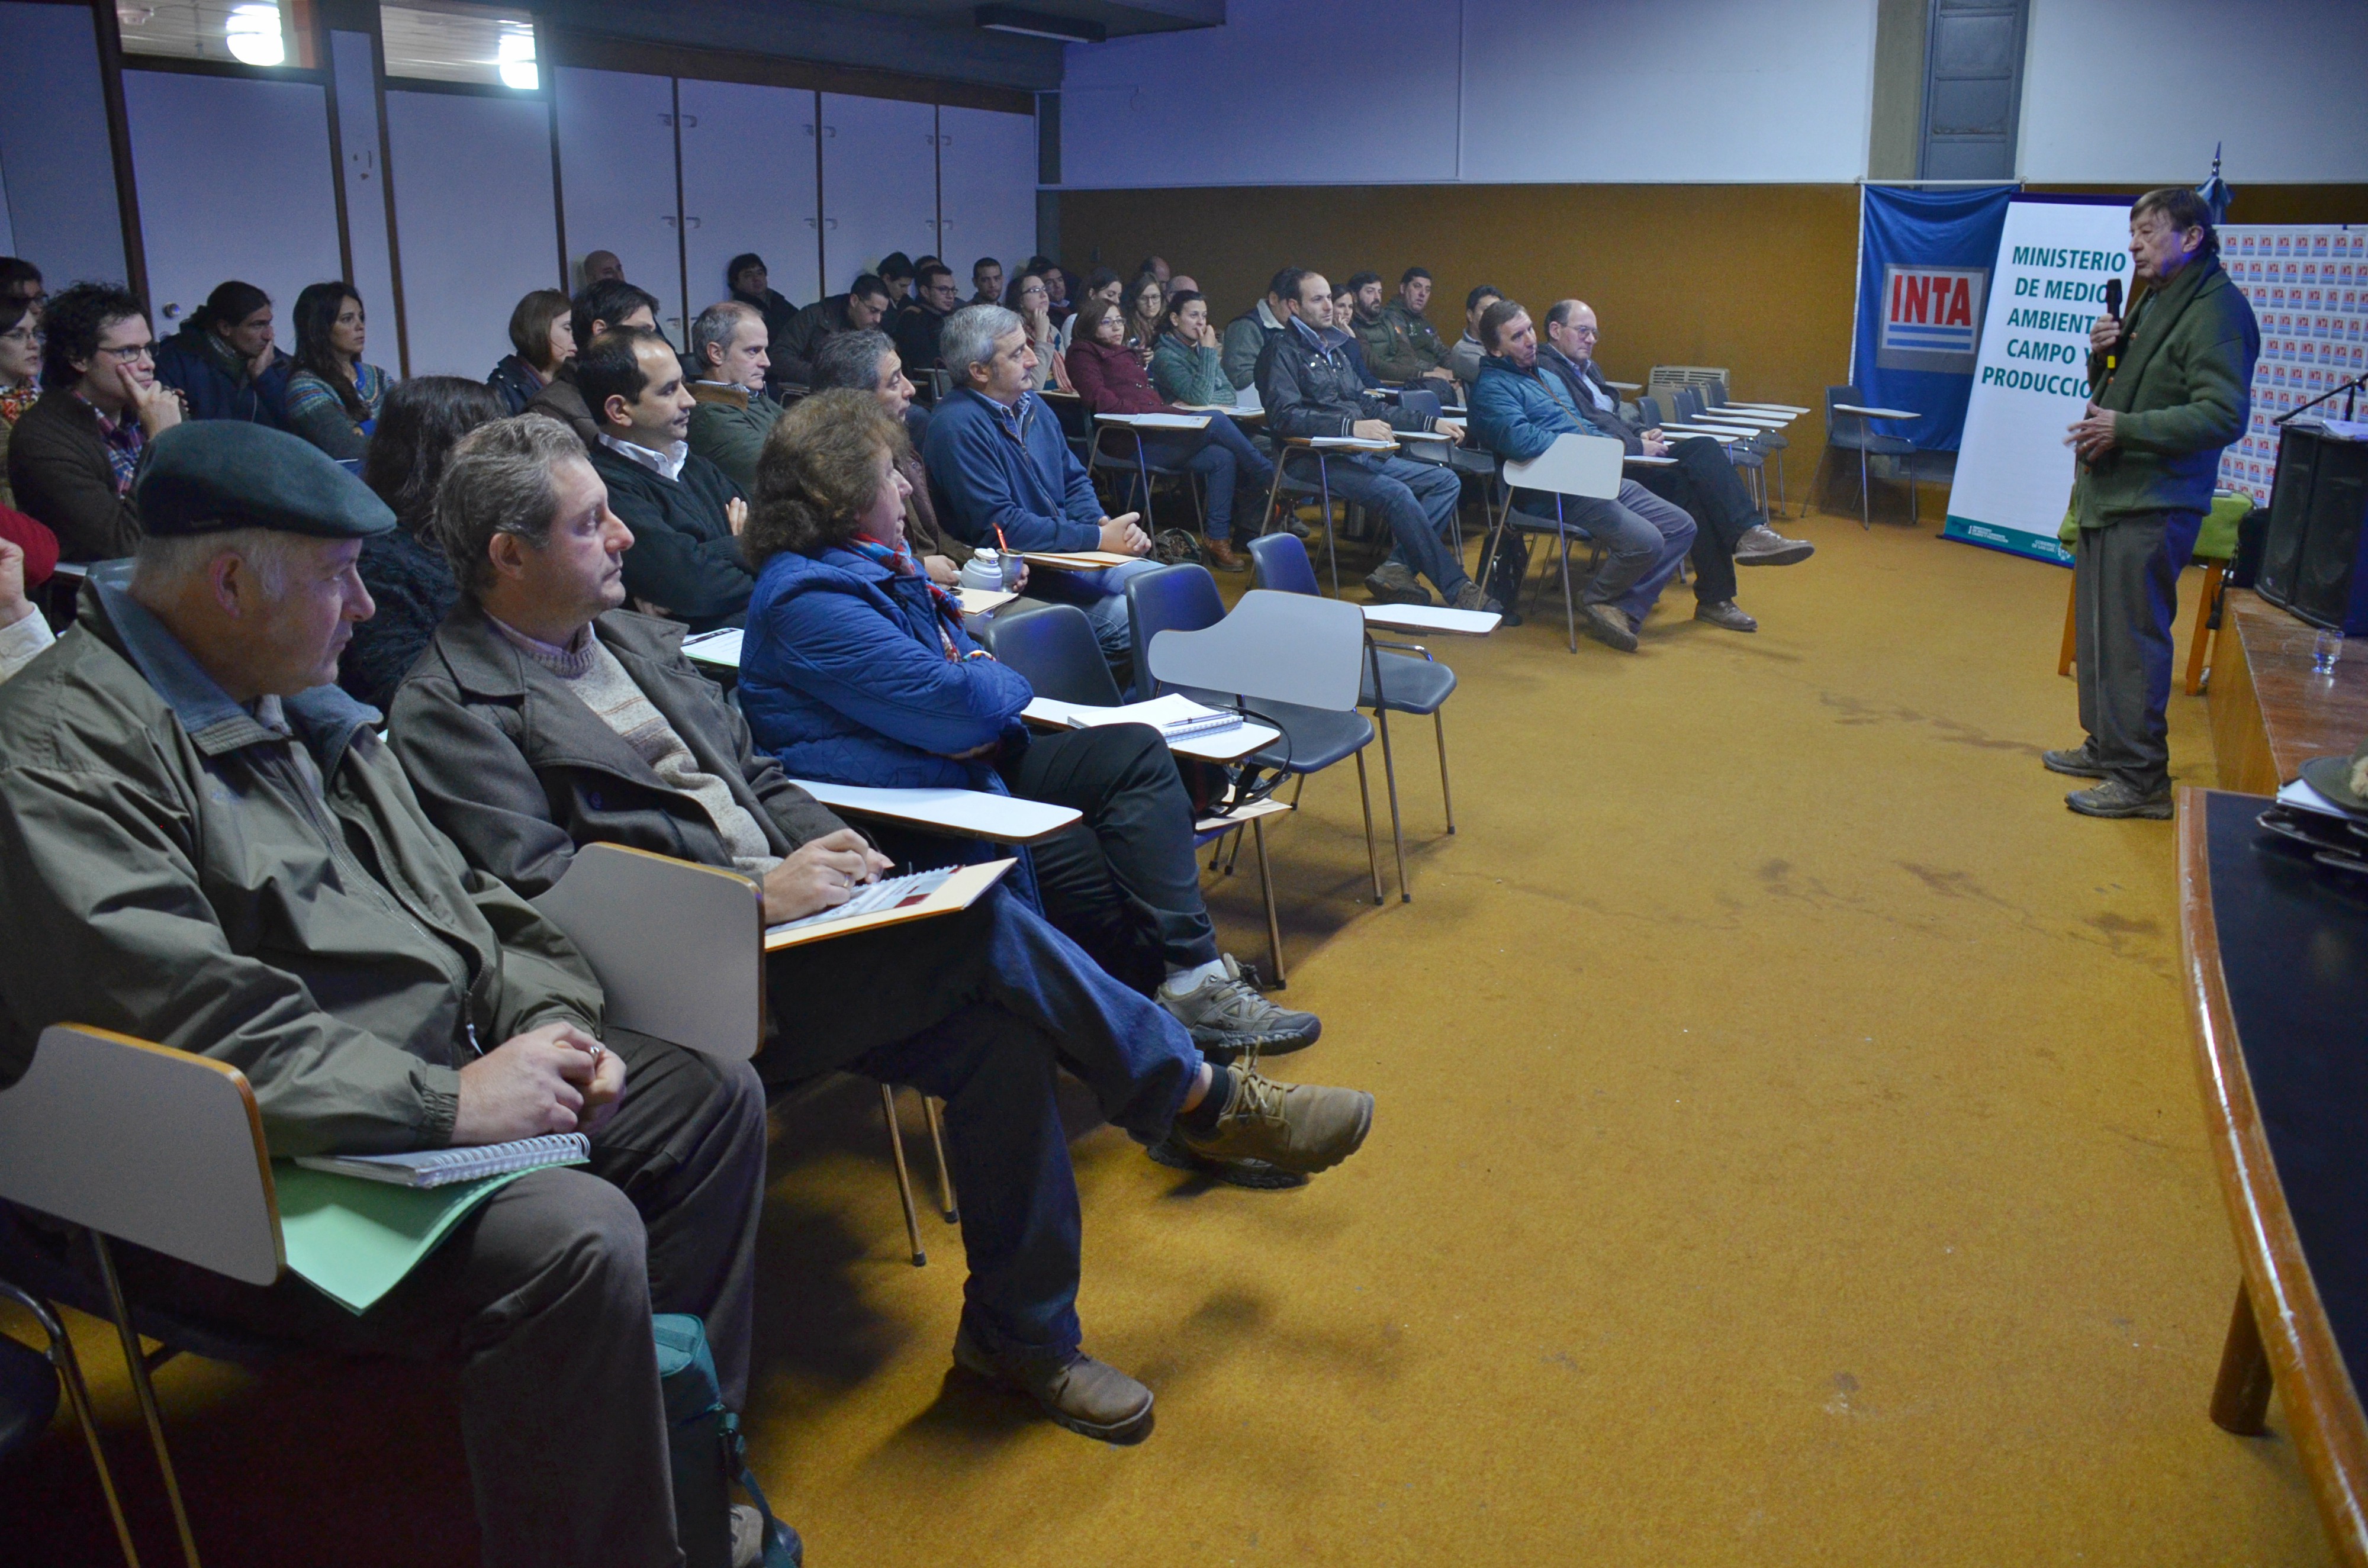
left=1127, top=566, right=1407, bottom=905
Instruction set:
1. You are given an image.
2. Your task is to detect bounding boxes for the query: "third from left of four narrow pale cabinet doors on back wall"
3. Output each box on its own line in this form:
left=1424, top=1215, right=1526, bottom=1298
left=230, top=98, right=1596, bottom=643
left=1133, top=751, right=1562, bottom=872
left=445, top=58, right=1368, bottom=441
left=822, top=92, right=938, bottom=294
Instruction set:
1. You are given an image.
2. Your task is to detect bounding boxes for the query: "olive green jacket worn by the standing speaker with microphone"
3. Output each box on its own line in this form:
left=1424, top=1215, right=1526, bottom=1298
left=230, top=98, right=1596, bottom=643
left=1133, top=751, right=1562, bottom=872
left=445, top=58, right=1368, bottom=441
left=2079, top=256, right=2261, bottom=528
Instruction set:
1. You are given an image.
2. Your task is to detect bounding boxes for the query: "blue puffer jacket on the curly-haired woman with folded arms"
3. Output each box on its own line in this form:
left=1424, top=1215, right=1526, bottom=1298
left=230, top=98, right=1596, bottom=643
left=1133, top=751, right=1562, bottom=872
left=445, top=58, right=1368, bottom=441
left=739, top=545, right=1035, bottom=794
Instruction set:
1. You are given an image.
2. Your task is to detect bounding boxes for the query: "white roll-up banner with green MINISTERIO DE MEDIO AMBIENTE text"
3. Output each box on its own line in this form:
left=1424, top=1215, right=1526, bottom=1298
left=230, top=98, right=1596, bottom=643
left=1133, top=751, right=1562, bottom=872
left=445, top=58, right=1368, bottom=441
left=1942, top=194, right=2134, bottom=566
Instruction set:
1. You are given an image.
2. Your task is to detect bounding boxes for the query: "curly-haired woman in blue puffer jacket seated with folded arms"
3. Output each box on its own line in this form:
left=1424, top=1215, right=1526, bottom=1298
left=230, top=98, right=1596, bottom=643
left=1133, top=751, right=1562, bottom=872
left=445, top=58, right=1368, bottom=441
left=741, top=393, right=1321, bottom=1049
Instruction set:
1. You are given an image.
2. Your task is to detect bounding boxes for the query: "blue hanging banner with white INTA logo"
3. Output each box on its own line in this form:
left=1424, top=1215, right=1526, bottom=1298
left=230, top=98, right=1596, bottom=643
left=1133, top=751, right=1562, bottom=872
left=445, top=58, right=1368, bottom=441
left=1849, top=185, right=2015, bottom=452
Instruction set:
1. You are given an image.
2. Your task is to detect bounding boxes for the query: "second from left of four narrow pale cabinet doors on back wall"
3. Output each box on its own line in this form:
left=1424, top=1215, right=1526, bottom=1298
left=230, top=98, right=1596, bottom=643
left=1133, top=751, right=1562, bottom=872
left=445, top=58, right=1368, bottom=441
left=677, top=78, right=822, bottom=315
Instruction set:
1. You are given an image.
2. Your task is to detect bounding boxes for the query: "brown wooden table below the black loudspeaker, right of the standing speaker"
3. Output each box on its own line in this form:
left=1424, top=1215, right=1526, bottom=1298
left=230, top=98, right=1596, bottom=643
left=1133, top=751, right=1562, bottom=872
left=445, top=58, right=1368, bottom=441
left=2205, top=587, right=2368, bottom=796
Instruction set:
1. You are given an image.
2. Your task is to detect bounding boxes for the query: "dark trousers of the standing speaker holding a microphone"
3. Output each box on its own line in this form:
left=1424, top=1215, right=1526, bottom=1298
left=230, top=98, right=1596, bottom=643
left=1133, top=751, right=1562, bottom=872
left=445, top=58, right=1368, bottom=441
left=2072, top=511, right=2205, bottom=796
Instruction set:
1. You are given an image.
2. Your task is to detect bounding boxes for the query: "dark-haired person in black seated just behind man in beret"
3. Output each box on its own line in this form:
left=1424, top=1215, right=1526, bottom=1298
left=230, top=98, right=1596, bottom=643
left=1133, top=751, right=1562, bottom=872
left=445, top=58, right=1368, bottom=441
left=336, top=376, right=502, bottom=713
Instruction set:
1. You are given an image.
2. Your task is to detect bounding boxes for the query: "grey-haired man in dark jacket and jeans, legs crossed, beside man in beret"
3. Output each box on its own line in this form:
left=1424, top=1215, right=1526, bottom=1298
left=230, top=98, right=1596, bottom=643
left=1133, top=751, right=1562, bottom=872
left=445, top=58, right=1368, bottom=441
left=391, top=407, right=1371, bottom=1449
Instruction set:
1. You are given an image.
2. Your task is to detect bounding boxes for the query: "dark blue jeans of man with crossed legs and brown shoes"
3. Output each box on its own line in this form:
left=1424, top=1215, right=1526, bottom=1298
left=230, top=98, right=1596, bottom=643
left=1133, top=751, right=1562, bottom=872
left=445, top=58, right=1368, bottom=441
left=848, top=888, right=1201, bottom=1362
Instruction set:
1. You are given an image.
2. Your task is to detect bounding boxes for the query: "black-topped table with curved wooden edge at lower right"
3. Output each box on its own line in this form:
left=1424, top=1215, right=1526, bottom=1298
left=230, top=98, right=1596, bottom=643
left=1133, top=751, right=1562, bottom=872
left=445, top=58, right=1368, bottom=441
left=2179, top=789, right=2368, bottom=1568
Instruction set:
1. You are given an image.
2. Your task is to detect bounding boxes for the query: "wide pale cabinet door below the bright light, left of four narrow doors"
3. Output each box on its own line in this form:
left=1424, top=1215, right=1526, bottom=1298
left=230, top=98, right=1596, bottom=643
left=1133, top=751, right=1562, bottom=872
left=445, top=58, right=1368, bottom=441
left=386, top=92, right=559, bottom=381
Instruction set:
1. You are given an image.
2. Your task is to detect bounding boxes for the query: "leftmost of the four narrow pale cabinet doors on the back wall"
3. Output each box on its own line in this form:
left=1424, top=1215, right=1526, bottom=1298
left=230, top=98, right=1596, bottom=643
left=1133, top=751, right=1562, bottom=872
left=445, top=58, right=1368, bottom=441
left=552, top=66, right=684, bottom=346
